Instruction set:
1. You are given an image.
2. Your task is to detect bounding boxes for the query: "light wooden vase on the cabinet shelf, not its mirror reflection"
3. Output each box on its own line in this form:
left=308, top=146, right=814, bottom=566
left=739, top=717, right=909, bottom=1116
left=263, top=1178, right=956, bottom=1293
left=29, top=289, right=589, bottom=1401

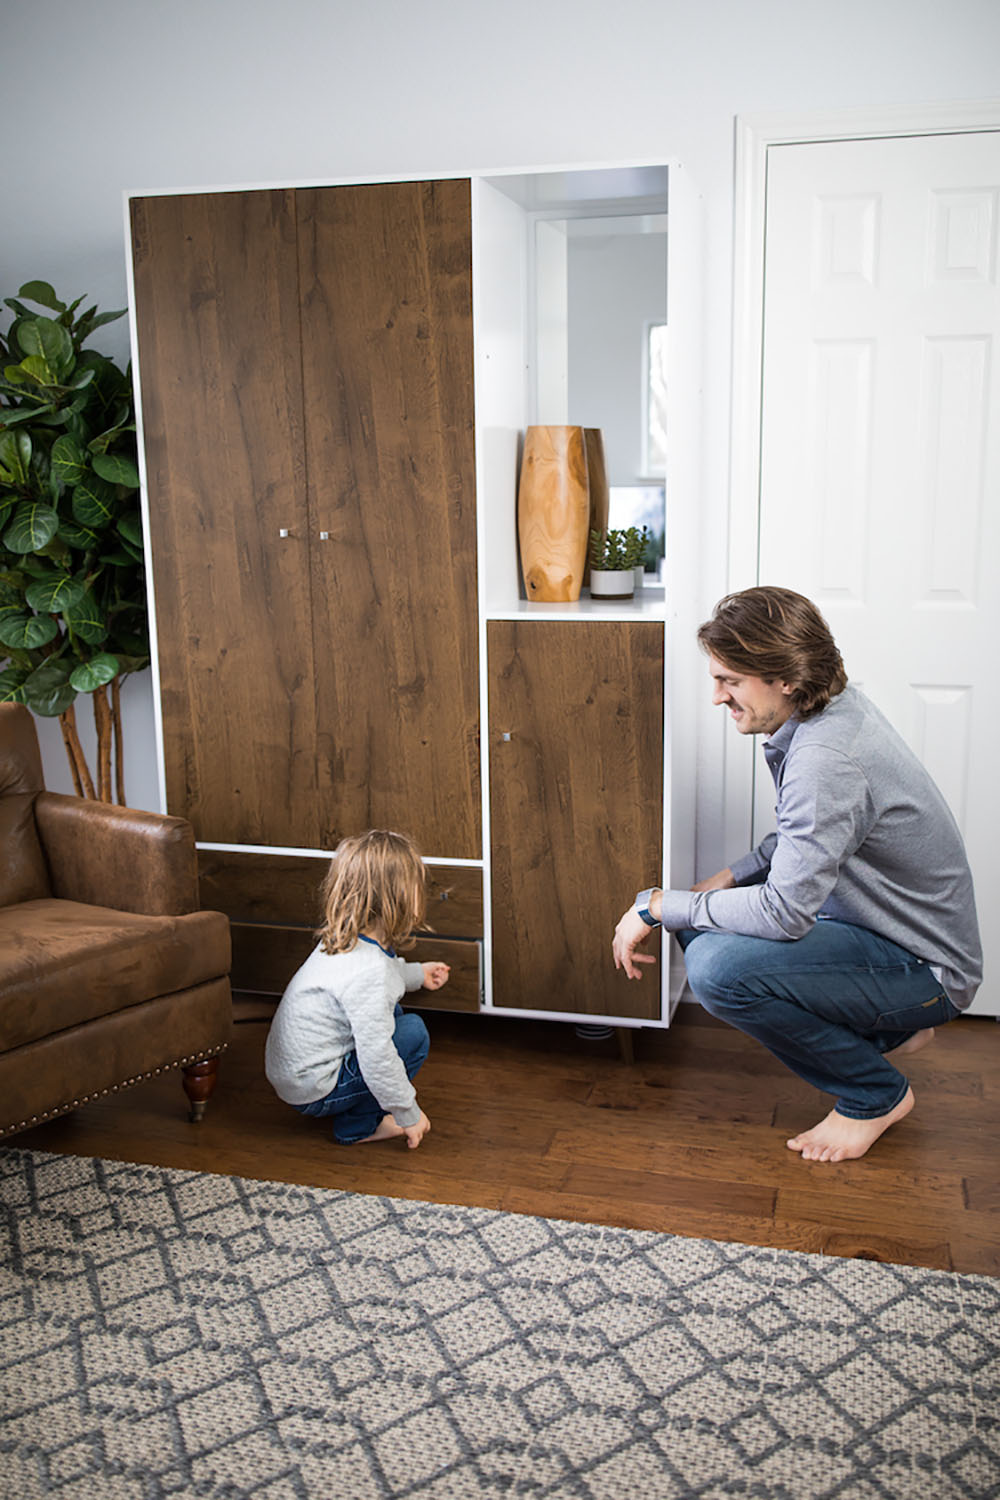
left=517, top=428, right=591, bottom=605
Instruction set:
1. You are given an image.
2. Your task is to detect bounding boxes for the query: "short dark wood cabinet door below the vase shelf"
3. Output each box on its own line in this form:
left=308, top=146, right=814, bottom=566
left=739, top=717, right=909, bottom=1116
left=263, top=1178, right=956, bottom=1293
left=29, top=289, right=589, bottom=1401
left=487, top=620, right=663, bottom=1020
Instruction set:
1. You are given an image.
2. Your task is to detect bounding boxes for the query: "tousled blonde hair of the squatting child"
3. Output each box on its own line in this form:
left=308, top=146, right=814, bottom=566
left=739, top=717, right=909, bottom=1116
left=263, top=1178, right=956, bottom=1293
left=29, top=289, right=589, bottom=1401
left=316, top=828, right=427, bottom=953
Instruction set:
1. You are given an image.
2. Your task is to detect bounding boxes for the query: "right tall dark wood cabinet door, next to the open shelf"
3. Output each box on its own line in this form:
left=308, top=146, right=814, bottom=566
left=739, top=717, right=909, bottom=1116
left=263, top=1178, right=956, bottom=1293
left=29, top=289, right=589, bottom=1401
left=297, top=180, right=479, bottom=860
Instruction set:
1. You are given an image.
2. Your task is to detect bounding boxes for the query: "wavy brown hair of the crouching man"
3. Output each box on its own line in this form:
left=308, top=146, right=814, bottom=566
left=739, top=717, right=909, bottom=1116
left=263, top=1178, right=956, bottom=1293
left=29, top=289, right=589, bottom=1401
left=697, top=587, right=847, bottom=719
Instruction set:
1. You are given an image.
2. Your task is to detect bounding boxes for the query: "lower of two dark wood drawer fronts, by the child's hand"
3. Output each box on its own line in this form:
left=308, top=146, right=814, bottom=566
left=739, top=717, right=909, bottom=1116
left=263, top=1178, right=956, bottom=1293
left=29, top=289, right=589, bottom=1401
left=231, top=923, right=481, bottom=1011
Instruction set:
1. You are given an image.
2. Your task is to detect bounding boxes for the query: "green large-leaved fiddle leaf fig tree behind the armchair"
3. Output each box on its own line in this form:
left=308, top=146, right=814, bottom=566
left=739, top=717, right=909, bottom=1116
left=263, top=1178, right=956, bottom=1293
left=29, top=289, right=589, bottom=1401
left=0, top=281, right=150, bottom=803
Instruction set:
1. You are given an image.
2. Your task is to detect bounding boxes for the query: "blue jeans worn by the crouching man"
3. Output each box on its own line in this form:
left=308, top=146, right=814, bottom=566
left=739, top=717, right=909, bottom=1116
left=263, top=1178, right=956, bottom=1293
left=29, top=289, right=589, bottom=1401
left=676, top=920, right=960, bottom=1121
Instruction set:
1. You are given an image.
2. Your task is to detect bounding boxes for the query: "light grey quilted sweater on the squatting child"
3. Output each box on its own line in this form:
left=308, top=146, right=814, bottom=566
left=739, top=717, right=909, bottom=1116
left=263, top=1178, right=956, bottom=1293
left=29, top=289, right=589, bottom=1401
left=264, top=939, right=424, bottom=1125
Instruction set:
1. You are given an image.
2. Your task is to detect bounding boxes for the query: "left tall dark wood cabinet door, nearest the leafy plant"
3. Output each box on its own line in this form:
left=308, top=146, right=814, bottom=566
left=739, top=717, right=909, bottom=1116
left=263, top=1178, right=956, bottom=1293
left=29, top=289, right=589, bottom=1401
left=132, top=191, right=316, bottom=848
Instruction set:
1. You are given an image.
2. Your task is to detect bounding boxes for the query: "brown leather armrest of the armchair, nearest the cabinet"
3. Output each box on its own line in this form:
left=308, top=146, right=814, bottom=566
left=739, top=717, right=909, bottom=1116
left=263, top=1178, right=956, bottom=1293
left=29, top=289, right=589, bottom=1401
left=34, top=792, right=199, bottom=917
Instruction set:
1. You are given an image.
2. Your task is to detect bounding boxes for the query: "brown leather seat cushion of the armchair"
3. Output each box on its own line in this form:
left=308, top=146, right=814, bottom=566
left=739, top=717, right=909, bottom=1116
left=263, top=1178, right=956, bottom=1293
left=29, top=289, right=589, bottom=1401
left=0, top=899, right=229, bottom=1052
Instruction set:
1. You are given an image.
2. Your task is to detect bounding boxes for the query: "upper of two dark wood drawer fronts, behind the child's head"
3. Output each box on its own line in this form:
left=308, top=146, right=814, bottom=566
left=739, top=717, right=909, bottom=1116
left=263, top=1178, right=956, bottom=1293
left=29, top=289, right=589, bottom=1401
left=198, top=849, right=483, bottom=930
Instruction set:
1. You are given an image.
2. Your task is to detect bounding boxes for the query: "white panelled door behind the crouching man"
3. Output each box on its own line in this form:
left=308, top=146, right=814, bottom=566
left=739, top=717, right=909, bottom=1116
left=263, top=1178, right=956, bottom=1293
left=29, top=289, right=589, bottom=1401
left=756, top=131, right=1000, bottom=1014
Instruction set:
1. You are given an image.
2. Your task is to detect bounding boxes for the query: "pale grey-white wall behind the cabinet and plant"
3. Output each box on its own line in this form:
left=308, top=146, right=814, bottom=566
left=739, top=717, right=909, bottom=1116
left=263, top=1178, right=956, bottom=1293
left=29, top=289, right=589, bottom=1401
left=0, top=0, right=1000, bottom=881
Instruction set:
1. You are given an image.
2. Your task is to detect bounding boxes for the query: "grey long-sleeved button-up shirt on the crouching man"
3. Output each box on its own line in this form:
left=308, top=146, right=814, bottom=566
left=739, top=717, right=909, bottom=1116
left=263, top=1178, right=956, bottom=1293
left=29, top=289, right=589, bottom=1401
left=663, top=686, right=982, bottom=1010
